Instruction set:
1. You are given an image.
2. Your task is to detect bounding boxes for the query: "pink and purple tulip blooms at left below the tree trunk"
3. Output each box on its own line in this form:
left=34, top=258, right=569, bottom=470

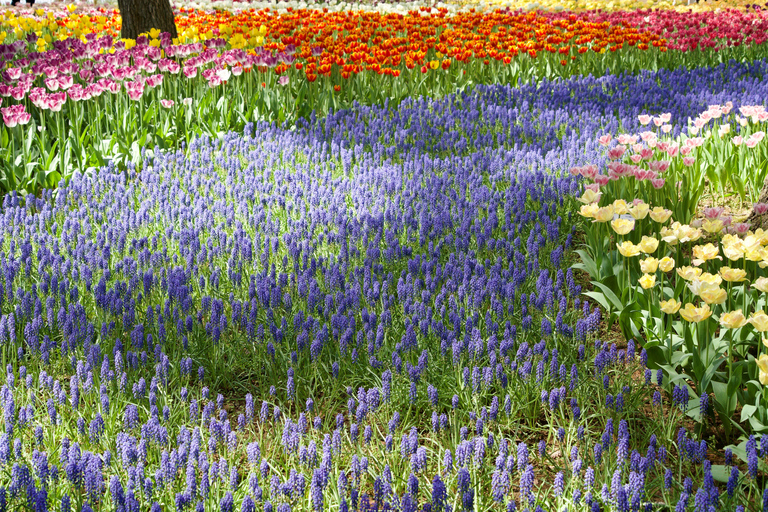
left=0, top=34, right=282, bottom=124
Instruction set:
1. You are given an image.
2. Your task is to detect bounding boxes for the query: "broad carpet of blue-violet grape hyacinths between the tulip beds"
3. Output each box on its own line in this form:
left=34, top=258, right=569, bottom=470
left=0, top=61, right=768, bottom=512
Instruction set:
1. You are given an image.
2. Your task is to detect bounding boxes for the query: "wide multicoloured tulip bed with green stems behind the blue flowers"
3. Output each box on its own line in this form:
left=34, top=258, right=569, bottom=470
left=0, top=3, right=768, bottom=192
